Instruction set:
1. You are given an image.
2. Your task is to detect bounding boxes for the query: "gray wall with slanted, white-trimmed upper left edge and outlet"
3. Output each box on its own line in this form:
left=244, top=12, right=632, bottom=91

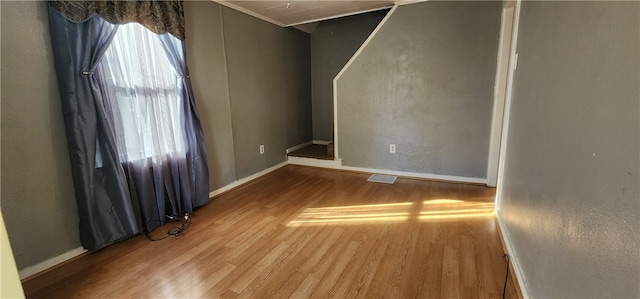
left=338, top=1, right=501, bottom=178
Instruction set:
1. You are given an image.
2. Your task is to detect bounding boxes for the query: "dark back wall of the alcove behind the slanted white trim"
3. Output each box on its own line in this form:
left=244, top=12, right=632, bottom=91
left=311, top=10, right=388, bottom=141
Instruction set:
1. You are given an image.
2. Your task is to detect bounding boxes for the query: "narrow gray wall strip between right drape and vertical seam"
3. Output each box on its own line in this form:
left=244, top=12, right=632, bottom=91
left=184, top=1, right=236, bottom=190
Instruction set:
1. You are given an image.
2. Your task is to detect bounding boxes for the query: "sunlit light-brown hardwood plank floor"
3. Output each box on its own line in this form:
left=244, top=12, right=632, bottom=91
left=23, top=166, right=516, bottom=298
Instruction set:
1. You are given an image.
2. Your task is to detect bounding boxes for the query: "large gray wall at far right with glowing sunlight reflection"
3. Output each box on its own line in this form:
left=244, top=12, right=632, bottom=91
left=498, top=1, right=640, bottom=298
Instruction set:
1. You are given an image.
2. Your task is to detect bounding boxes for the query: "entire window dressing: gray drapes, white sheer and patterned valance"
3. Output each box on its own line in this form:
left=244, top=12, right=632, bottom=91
left=47, top=1, right=209, bottom=246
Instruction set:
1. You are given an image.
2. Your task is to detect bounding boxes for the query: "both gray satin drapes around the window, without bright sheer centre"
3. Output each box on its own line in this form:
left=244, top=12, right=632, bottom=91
left=48, top=5, right=209, bottom=250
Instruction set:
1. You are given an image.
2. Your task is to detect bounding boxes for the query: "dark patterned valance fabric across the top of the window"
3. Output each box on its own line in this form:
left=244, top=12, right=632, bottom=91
left=49, top=1, right=184, bottom=40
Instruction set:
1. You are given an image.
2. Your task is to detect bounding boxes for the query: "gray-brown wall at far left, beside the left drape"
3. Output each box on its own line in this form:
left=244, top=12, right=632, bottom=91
left=0, top=1, right=81, bottom=269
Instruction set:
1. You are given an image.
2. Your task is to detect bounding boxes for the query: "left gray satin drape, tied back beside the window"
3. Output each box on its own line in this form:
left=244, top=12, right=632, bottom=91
left=48, top=6, right=142, bottom=250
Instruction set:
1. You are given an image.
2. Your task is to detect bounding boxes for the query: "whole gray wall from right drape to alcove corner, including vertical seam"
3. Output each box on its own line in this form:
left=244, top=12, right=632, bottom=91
left=185, top=2, right=312, bottom=182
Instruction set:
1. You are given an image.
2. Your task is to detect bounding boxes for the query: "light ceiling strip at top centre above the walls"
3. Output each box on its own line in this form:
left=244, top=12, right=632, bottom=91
left=214, top=0, right=395, bottom=31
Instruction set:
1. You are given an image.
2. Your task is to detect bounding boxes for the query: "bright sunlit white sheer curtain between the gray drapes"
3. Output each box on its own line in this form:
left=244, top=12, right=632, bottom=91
left=97, top=23, right=186, bottom=164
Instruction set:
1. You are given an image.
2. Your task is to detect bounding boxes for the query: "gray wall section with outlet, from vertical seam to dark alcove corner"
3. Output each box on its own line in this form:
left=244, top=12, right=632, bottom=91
left=222, top=7, right=311, bottom=178
